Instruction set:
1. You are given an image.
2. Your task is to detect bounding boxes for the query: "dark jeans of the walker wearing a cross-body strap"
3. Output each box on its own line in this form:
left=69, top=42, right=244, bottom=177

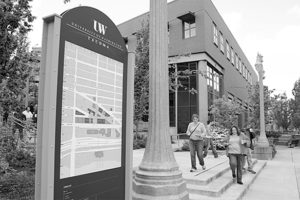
left=189, top=140, right=204, bottom=169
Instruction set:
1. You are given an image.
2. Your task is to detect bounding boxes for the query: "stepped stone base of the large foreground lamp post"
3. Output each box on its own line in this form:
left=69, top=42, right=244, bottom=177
left=132, top=169, right=189, bottom=200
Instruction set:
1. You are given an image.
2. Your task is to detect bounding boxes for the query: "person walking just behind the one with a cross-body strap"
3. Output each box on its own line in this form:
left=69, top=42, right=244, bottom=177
left=203, top=121, right=218, bottom=158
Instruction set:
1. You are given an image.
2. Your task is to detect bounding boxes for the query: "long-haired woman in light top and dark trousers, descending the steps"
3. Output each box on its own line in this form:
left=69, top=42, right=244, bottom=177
left=226, top=126, right=250, bottom=185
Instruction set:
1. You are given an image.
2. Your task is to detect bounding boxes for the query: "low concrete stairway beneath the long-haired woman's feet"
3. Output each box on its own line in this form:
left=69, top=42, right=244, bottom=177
left=183, top=160, right=266, bottom=200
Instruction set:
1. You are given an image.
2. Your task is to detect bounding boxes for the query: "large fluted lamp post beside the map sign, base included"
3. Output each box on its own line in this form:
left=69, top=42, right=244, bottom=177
left=133, top=0, right=189, bottom=200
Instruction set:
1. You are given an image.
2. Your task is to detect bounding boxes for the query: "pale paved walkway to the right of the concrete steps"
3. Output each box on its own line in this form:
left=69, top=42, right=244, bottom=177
left=243, top=146, right=300, bottom=200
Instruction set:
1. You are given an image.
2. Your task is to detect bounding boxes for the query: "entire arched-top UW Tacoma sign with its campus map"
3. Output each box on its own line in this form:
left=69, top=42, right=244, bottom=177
left=35, top=7, right=127, bottom=200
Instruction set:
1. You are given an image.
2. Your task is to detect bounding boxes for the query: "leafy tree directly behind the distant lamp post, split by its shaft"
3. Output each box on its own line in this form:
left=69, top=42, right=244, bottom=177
left=247, top=82, right=274, bottom=129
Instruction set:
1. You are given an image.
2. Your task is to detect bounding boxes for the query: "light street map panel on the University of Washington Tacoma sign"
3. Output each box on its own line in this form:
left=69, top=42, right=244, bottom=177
left=60, top=41, right=123, bottom=179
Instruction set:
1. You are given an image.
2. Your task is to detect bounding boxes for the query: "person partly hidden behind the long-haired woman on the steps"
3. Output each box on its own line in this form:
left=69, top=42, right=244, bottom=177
left=243, top=128, right=256, bottom=174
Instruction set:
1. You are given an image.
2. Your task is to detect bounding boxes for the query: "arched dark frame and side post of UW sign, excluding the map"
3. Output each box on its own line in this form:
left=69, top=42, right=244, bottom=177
left=35, top=6, right=128, bottom=200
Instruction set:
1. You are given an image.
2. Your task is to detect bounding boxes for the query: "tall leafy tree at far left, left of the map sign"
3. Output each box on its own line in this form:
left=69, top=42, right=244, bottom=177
left=0, top=0, right=34, bottom=112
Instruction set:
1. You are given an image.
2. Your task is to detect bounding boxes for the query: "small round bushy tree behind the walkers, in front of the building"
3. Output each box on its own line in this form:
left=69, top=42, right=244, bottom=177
left=209, top=96, right=242, bottom=129
